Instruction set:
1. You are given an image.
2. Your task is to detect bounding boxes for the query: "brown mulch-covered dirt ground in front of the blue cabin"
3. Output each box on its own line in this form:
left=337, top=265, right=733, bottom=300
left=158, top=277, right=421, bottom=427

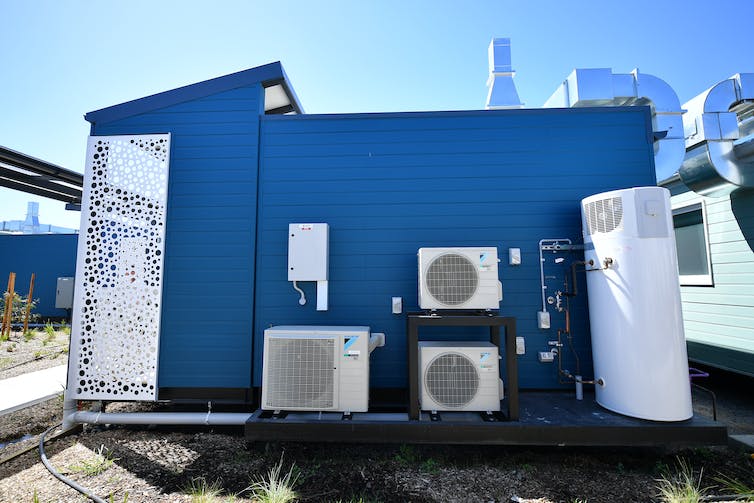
left=0, top=330, right=754, bottom=503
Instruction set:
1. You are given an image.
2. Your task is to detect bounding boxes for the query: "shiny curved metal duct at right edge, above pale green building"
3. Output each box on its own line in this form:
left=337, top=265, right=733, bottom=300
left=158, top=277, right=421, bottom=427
left=678, top=73, right=754, bottom=197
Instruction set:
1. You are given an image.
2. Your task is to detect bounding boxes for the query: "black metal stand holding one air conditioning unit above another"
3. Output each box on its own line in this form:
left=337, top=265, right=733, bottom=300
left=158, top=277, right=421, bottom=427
left=406, top=313, right=519, bottom=421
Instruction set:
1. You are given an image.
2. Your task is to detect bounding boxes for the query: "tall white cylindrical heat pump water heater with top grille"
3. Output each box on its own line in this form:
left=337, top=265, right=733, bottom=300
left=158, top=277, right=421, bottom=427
left=581, top=187, right=693, bottom=421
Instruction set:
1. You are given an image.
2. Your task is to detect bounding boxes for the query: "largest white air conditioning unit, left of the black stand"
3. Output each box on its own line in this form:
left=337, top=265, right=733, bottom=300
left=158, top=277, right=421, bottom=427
left=262, top=326, right=384, bottom=412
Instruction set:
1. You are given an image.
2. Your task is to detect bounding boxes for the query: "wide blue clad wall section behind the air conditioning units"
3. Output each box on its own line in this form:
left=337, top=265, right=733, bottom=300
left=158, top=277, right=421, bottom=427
left=253, top=107, right=655, bottom=388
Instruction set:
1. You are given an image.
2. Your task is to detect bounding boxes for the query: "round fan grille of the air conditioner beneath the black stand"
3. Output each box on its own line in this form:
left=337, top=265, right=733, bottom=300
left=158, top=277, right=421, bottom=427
left=424, top=353, right=479, bottom=407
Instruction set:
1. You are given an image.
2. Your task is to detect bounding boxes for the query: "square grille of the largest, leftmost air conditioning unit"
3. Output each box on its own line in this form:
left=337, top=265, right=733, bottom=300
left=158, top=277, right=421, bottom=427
left=264, top=337, right=335, bottom=409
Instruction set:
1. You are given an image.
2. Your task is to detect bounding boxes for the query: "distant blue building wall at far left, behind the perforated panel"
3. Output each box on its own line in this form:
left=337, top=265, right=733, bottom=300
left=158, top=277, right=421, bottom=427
left=0, top=234, right=78, bottom=321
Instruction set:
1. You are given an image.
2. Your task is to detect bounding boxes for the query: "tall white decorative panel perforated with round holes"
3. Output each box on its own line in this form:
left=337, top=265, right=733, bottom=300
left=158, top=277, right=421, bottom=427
left=67, top=134, right=170, bottom=400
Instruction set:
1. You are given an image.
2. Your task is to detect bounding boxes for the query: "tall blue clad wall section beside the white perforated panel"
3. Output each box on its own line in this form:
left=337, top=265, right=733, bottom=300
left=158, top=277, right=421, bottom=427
left=87, top=83, right=264, bottom=388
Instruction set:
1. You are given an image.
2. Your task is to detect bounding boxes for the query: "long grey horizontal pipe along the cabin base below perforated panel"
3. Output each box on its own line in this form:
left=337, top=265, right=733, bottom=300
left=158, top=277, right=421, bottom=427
left=66, top=411, right=253, bottom=426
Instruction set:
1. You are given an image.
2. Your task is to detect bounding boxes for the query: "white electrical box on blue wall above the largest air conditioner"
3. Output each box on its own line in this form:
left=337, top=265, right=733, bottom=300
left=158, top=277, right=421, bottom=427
left=288, top=224, right=330, bottom=281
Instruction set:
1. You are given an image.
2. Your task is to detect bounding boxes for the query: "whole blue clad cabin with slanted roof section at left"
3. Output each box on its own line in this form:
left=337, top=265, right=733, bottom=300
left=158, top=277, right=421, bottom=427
left=86, top=63, right=655, bottom=403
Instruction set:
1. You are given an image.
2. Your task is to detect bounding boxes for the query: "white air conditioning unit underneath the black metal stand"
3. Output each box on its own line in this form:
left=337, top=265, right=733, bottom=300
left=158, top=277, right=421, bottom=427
left=419, top=341, right=502, bottom=412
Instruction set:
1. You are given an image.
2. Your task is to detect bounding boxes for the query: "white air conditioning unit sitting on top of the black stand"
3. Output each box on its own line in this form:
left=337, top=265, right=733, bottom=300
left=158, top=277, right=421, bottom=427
left=419, top=247, right=503, bottom=309
